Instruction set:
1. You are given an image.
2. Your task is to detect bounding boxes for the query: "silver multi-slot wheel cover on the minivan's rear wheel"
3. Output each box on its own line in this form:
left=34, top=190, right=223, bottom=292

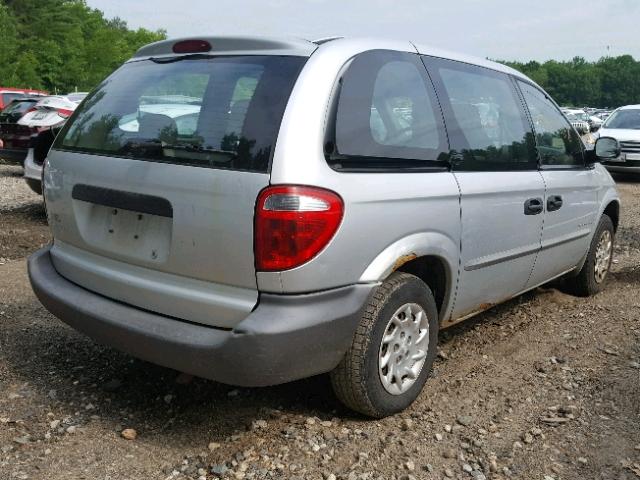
left=378, top=303, right=429, bottom=395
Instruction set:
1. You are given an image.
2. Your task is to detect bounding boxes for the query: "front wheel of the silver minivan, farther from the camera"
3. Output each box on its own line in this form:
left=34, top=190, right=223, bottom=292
left=565, top=214, right=615, bottom=297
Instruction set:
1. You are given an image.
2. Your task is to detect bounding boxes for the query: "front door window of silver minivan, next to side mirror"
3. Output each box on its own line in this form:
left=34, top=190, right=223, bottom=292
left=518, top=81, right=584, bottom=166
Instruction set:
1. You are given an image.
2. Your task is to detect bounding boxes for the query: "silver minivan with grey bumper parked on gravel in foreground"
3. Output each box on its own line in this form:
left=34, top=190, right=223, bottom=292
left=29, top=37, right=620, bottom=417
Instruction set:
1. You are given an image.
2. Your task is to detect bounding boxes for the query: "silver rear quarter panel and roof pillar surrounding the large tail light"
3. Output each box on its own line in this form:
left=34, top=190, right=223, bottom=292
left=257, top=39, right=460, bottom=293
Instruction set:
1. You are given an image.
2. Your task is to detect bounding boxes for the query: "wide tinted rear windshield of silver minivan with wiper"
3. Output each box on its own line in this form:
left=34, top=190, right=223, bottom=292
left=54, top=56, right=306, bottom=172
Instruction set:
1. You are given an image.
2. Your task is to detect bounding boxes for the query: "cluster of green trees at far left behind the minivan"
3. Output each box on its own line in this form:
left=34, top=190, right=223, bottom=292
left=0, top=0, right=166, bottom=92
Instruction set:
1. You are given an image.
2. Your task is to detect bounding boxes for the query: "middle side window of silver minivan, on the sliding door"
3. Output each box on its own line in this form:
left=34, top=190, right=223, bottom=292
left=425, top=57, right=537, bottom=171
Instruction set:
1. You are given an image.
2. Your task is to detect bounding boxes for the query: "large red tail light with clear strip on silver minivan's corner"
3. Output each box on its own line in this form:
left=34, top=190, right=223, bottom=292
left=255, top=186, right=344, bottom=272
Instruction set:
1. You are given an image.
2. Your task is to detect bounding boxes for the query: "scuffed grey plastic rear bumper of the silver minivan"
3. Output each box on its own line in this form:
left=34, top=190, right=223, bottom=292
left=28, top=247, right=375, bottom=387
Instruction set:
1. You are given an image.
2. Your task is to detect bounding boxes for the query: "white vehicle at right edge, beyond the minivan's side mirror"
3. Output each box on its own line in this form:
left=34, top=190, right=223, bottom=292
left=598, top=105, right=640, bottom=173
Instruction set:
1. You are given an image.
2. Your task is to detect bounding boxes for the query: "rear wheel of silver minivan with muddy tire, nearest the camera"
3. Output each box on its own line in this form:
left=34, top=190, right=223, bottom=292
left=331, top=272, right=439, bottom=418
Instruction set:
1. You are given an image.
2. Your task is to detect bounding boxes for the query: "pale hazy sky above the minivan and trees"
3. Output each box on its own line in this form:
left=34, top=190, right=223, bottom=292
left=87, top=0, right=640, bottom=61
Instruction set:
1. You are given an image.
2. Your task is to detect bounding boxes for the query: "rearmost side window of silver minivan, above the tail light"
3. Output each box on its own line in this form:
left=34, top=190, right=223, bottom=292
left=326, top=50, right=447, bottom=169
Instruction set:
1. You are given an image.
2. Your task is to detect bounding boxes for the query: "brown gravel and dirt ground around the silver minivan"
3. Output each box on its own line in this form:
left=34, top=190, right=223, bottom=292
left=0, top=166, right=640, bottom=480
